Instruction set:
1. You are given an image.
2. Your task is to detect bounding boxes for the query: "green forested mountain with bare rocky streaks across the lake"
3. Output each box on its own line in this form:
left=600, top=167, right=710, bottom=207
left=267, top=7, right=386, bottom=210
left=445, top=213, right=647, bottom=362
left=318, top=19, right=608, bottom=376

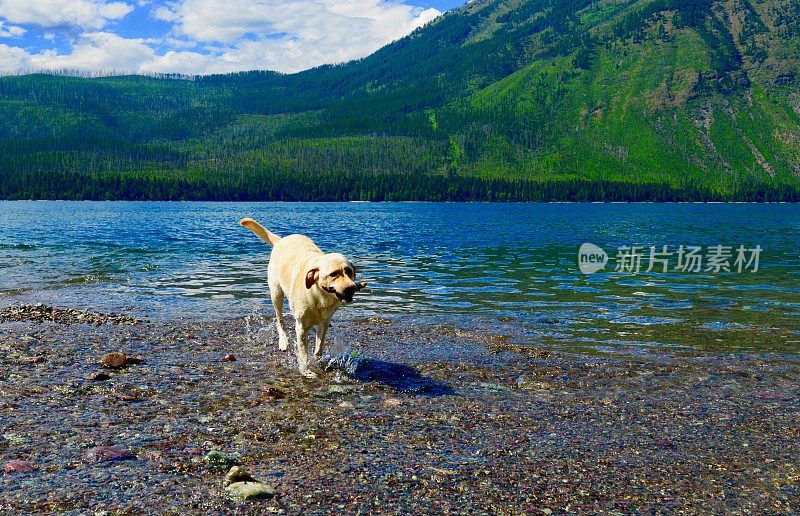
left=0, top=0, right=800, bottom=201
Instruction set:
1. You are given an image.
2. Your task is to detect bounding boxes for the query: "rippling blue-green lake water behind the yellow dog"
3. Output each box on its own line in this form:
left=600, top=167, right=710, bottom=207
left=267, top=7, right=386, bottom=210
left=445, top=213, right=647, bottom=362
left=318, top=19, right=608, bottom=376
left=0, top=201, right=800, bottom=354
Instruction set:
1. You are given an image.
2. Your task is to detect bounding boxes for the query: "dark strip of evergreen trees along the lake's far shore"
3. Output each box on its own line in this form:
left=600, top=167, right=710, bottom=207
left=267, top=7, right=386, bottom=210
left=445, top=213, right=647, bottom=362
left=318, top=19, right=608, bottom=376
left=0, top=169, right=800, bottom=202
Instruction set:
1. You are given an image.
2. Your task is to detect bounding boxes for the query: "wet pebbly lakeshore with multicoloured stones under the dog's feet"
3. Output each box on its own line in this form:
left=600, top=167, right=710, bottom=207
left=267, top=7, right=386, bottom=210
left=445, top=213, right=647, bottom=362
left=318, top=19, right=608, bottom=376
left=0, top=305, right=800, bottom=514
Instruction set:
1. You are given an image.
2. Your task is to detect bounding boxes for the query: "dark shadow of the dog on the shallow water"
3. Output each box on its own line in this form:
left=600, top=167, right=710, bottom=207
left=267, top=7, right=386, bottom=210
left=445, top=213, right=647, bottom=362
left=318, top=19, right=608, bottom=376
left=326, top=355, right=455, bottom=397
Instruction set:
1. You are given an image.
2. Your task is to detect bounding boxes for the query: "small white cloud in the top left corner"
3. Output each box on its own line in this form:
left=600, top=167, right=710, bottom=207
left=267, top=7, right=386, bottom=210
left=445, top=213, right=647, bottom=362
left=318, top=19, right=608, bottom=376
left=0, top=0, right=133, bottom=30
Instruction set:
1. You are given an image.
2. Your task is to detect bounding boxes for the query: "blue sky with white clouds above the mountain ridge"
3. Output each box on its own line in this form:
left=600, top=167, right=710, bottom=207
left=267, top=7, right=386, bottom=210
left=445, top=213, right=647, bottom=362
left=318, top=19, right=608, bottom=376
left=0, top=0, right=464, bottom=75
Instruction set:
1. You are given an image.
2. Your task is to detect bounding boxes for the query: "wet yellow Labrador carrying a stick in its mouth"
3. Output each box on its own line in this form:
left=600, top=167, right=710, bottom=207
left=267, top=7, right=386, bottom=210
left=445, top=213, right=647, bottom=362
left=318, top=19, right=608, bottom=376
left=239, top=218, right=367, bottom=378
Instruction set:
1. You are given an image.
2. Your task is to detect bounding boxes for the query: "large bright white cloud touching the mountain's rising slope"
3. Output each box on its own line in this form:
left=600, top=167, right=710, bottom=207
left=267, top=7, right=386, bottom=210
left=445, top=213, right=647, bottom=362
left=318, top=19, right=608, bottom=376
left=148, top=0, right=441, bottom=73
